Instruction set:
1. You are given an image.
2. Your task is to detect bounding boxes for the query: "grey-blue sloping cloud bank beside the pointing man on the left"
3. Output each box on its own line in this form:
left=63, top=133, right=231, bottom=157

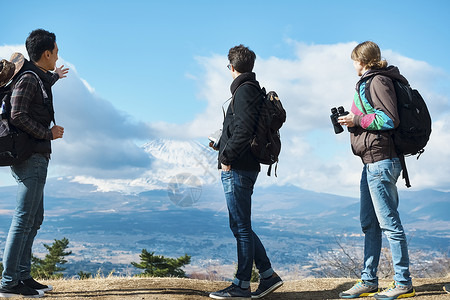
left=0, top=46, right=154, bottom=184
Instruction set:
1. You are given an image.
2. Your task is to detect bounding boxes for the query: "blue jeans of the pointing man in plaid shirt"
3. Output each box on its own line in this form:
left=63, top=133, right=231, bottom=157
left=1, top=154, right=48, bottom=288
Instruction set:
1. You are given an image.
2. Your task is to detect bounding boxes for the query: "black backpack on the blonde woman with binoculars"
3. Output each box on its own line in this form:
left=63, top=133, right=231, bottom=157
left=365, top=77, right=431, bottom=187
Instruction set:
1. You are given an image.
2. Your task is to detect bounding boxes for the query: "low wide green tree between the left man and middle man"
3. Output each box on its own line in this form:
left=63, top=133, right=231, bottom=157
left=131, top=249, right=191, bottom=277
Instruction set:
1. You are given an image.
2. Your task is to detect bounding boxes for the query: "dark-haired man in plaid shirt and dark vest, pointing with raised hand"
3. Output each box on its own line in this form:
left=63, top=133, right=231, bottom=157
left=0, top=29, right=68, bottom=298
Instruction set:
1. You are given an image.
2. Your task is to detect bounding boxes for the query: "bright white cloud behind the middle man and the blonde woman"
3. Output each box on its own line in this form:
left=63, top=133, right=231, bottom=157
left=159, top=41, right=450, bottom=196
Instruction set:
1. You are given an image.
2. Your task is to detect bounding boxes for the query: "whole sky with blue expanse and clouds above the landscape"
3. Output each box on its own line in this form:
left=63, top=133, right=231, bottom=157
left=0, top=0, right=450, bottom=193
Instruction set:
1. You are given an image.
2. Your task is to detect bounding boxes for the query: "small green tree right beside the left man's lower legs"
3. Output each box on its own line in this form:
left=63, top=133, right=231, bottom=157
left=31, top=238, right=72, bottom=279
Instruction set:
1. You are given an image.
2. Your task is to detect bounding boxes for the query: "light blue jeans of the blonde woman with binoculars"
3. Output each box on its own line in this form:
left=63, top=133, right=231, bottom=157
left=360, top=158, right=411, bottom=284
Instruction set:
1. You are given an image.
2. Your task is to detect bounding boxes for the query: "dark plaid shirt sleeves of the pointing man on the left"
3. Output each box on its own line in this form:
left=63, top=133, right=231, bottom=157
left=11, top=73, right=59, bottom=140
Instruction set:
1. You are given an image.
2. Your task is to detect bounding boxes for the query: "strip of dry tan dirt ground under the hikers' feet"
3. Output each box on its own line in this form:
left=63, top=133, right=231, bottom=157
left=39, top=277, right=450, bottom=300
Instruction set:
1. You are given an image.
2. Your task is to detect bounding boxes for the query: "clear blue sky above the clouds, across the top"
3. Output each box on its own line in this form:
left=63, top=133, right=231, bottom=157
left=0, top=0, right=450, bottom=123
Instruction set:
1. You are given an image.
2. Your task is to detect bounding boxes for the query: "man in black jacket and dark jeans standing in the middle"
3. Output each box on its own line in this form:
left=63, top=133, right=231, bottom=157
left=210, top=45, right=283, bottom=299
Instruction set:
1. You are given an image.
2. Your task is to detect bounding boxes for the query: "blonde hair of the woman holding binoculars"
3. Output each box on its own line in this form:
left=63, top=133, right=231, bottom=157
left=351, top=41, right=388, bottom=70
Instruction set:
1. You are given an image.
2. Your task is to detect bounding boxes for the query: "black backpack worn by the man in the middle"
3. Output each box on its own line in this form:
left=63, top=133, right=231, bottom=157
left=234, top=81, right=286, bottom=176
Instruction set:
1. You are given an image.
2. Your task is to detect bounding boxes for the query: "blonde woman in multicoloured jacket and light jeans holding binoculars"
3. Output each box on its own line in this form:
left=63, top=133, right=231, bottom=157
left=339, top=41, right=415, bottom=300
